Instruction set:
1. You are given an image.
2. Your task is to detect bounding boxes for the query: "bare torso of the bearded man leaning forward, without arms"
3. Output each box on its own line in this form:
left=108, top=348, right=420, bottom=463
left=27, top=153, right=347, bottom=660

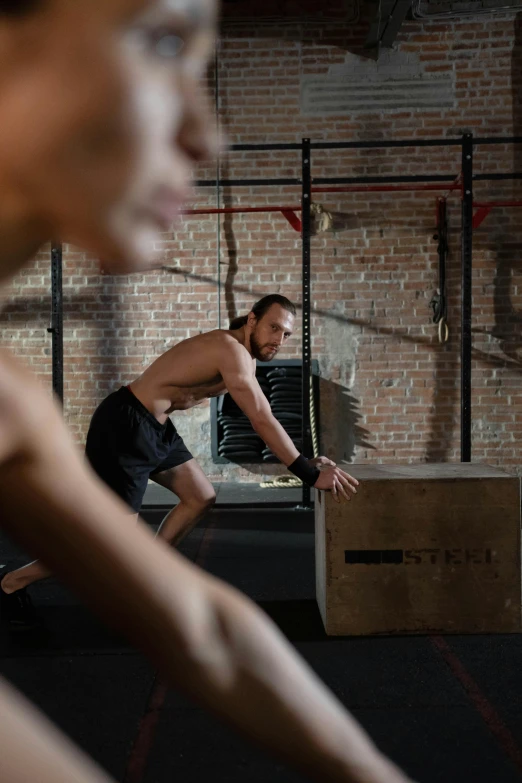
left=130, top=329, right=255, bottom=424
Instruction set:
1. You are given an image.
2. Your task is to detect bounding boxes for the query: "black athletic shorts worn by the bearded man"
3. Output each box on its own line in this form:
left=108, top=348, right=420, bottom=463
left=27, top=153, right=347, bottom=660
left=85, top=386, right=192, bottom=513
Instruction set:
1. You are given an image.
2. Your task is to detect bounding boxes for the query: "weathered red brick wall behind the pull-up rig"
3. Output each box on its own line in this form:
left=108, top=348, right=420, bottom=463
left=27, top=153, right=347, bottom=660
left=4, top=13, right=522, bottom=481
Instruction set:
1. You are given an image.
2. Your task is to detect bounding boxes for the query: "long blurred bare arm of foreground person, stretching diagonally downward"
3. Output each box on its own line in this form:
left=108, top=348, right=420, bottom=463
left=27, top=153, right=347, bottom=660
left=0, top=354, right=414, bottom=783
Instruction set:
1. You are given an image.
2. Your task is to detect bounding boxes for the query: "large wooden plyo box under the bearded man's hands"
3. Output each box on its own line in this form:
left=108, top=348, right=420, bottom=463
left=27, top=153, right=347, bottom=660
left=315, top=463, right=522, bottom=636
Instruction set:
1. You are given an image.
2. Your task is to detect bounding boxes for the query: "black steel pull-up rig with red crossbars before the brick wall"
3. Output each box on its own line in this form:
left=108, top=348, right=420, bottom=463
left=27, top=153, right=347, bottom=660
left=49, top=133, right=522, bottom=506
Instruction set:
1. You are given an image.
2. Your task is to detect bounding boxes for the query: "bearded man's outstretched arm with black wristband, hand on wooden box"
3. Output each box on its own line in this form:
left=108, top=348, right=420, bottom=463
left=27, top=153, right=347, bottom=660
left=219, top=344, right=358, bottom=500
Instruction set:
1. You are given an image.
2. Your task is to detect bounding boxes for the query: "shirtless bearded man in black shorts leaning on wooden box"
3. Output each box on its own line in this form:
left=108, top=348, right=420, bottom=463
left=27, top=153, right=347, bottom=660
left=0, top=294, right=358, bottom=608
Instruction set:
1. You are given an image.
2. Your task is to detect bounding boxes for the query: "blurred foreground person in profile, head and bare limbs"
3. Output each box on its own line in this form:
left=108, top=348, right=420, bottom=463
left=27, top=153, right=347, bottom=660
left=0, top=0, right=414, bottom=783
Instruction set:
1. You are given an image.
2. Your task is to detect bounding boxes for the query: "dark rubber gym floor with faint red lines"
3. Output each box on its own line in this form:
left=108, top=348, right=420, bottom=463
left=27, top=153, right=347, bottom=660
left=0, top=485, right=522, bottom=783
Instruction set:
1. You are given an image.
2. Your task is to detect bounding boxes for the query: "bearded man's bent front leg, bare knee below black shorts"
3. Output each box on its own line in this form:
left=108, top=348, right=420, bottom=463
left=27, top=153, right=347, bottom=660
left=151, top=459, right=216, bottom=546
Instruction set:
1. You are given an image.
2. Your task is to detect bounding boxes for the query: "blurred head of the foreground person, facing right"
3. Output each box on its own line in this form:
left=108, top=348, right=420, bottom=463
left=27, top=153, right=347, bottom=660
left=0, top=0, right=216, bottom=272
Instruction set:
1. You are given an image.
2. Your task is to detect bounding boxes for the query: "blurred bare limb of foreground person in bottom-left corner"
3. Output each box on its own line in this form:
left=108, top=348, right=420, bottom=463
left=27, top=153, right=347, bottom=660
left=0, top=681, right=114, bottom=783
